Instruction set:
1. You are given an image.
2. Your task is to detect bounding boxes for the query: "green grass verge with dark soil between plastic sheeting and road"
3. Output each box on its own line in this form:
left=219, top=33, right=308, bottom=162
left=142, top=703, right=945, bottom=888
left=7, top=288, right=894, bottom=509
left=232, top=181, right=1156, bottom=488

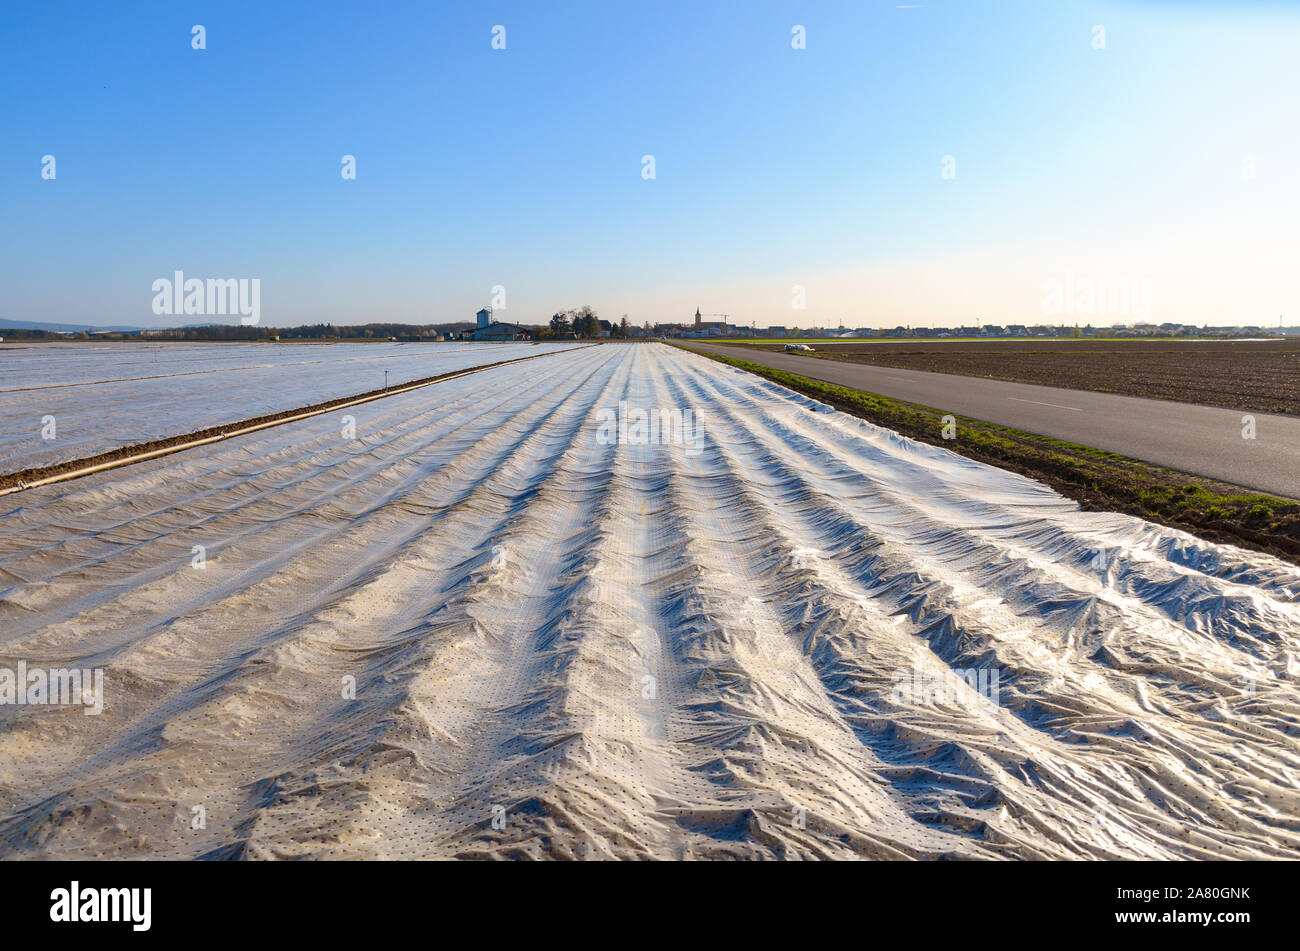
left=672, top=344, right=1300, bottom=564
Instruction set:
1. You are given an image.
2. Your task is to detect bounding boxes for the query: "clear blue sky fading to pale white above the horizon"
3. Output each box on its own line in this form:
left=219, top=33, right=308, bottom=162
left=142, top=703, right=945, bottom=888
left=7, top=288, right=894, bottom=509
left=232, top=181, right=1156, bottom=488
left=0, top=0, right=1300, bottom=326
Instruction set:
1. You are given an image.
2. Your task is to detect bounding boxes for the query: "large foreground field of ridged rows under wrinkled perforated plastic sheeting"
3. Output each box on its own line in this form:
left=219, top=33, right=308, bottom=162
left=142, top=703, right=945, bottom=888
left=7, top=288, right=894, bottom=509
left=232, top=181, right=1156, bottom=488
left=0, top=343, right=1300, bottom=859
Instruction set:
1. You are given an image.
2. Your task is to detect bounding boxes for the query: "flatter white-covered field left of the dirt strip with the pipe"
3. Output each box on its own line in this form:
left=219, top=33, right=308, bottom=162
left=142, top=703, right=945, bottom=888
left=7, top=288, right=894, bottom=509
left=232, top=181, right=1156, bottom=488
left=0, top=343, right=571, bottom=474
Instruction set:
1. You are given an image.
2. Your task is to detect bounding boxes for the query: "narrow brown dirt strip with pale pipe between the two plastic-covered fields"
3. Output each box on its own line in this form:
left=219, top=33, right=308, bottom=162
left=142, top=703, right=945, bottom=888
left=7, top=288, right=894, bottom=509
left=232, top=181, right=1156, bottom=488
left=0, top=344, right=592, bottom=495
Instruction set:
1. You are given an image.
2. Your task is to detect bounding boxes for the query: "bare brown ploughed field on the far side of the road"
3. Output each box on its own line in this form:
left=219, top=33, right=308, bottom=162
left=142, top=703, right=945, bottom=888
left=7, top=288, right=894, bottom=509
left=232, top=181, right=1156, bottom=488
left=737, top=338, right=1300, bottom=414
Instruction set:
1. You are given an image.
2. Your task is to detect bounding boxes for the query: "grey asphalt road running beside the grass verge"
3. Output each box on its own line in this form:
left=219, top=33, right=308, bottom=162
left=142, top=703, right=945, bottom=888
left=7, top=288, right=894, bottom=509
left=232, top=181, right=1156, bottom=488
left=688, top=342, right=1300, bottom=499
